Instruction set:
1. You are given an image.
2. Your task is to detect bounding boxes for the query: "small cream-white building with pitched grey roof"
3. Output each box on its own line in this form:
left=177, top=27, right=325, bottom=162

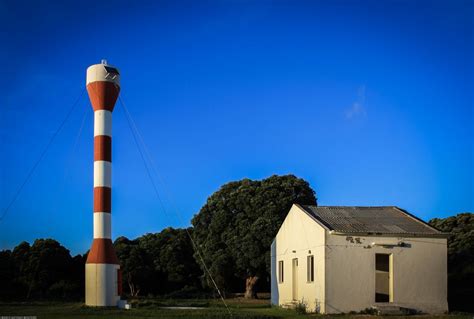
left=271, top=205, right=448, bottom=313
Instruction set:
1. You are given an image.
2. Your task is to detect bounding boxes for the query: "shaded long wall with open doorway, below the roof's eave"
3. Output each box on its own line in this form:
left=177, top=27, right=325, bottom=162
left=326, top=233, right=448, bottom=313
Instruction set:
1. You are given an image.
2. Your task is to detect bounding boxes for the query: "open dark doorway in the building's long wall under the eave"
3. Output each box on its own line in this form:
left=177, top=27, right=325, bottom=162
left=375, top=254, right=393, bottom=302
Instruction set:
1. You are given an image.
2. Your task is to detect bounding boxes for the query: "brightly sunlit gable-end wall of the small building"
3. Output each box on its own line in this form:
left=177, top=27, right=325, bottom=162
left=271, top=205, right=325, bottom=312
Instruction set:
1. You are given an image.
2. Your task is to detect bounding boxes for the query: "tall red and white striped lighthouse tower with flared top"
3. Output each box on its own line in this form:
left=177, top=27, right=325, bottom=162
left=86, top=60, right=122, bottom=306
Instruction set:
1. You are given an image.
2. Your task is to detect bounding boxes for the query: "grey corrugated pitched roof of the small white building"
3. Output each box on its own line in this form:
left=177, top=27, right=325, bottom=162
left=298, top=205, right=446, bottom=237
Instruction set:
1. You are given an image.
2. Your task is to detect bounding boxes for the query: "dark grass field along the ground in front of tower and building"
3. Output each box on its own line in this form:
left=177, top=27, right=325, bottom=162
left=0, top=298, right=473, bottom=319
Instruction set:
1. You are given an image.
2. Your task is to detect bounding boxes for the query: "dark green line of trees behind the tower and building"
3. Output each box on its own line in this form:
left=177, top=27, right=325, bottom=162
left=0, top=175, right=474, bottom=311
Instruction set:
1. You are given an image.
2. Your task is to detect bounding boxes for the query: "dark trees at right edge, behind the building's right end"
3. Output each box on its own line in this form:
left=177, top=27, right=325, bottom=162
left=429, top=213, right=474, bottom=312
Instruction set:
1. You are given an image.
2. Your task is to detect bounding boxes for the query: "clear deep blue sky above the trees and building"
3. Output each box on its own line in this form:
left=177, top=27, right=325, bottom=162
left=0, top=0, right=474, bottom=253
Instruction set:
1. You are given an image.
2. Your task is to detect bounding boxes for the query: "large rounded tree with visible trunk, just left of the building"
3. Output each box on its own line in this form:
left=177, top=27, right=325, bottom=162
left=192, top=175, right=316, bottom=298
